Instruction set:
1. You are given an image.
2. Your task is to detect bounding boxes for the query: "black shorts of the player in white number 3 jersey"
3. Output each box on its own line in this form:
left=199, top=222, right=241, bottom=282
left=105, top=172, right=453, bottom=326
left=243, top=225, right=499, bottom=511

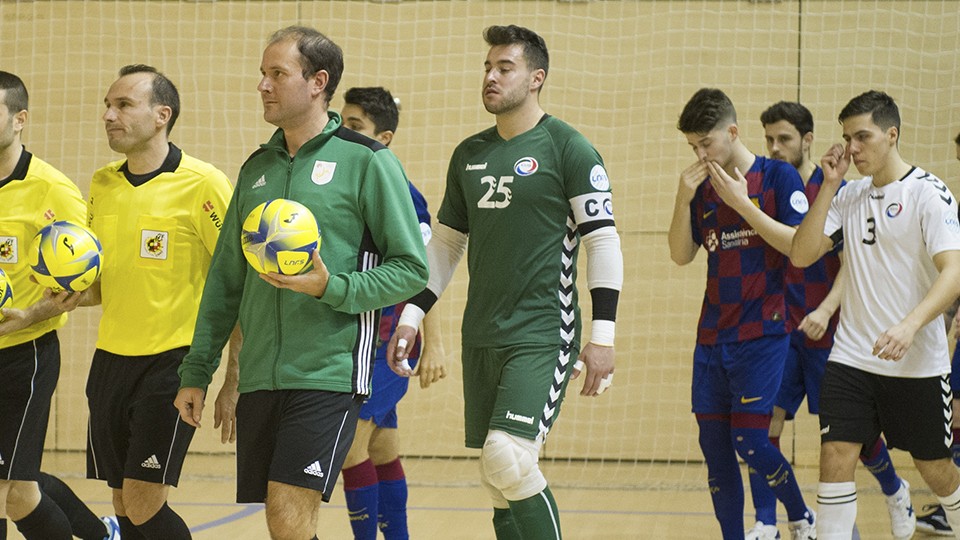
left=820, top=362, right=953, bottom=460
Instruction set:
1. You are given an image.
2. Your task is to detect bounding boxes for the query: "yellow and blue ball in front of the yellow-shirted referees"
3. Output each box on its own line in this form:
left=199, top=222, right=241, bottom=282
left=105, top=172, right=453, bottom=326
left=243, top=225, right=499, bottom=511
left=30, top=221, right=103, bottom=292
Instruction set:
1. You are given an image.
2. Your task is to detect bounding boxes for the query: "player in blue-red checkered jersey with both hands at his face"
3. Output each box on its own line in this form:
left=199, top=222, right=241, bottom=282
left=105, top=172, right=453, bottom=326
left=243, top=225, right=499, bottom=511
left=668, top=88, right=816, bottom=540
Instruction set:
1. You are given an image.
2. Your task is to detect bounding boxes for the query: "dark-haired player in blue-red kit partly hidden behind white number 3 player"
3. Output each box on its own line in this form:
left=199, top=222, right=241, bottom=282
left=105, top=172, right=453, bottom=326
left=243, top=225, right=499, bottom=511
left=746, top=101, right=915, bottom=540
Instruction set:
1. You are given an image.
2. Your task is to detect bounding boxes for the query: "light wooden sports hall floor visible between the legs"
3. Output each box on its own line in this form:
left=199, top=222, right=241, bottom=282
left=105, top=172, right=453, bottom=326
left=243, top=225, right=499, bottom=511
left=8, top=452, right=933, bottom=540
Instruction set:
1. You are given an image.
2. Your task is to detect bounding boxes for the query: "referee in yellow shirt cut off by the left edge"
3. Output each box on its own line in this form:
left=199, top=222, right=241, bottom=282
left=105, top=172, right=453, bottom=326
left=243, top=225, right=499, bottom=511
left=0, top=71, right=85, bottom=540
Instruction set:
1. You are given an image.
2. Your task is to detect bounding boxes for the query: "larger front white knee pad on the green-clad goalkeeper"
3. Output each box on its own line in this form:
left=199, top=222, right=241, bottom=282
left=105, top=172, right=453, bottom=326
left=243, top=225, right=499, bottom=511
left=480, top=430, right=547, bottom=501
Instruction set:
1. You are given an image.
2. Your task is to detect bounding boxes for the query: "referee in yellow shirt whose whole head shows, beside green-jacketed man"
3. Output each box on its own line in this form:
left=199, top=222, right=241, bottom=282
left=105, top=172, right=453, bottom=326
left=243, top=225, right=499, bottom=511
left=83, top=64, right=232, bottom=540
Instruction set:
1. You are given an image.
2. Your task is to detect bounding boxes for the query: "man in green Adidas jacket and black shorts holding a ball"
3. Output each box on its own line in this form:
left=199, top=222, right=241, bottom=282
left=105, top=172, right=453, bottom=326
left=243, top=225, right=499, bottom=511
left=175, top=27, right=427, bottom=538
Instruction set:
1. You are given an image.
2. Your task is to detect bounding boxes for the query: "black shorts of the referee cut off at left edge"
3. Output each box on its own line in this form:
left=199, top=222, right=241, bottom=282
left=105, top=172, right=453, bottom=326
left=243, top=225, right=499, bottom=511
left=0, top=331, right=60, bottom=481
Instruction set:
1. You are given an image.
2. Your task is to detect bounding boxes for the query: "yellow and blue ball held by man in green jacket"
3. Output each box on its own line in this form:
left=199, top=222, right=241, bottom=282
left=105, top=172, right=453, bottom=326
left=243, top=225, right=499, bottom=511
left=240, top=199, right=320, bottom=275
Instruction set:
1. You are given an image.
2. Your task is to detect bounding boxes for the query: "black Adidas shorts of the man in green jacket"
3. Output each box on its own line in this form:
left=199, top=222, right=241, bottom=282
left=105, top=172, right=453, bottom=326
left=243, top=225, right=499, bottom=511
left=237, top=390, right=365, bottom=503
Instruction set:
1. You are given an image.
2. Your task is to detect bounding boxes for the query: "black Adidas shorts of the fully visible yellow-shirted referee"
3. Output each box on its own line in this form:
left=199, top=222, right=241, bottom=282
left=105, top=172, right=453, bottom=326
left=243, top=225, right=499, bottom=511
left=87, top=347, right=194, bottom=489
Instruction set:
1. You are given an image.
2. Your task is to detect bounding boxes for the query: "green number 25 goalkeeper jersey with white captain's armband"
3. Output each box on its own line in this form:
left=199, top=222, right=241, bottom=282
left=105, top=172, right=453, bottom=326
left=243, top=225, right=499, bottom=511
left=437, top=115, right=613, bottom=347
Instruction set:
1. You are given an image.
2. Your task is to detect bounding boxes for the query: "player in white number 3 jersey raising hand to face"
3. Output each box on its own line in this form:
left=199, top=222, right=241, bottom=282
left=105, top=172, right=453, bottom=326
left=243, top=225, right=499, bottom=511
left=790, top=90, right=960, bottom=540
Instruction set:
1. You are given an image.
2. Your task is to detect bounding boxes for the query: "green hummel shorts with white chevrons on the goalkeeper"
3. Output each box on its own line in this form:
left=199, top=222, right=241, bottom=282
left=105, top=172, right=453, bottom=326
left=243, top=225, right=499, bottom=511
left=463, top=344, right=579, bottom=448
